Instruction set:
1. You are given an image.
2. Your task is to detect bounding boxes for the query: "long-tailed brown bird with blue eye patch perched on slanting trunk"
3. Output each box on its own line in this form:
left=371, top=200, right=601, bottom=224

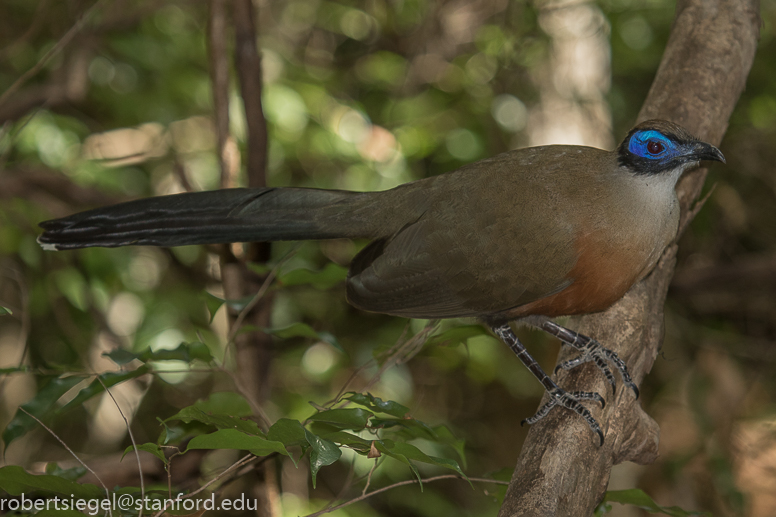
left=38, top=119, right=725, bottom=445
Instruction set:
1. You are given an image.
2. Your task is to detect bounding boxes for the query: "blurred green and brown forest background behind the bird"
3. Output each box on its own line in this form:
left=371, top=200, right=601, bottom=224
left=0, top=0, right=776, bottom=517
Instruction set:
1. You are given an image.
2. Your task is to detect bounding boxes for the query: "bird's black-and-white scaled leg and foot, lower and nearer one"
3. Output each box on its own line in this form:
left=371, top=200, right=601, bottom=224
left=491, top=324, right=606, bottom=445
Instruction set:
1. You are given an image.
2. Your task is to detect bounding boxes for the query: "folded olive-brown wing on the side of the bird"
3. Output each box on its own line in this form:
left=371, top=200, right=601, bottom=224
left=348, top=155, right=576, bottom=318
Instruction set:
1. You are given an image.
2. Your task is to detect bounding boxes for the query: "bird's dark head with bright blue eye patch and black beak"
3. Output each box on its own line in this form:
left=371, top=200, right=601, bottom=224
left=616, top=120, right=725, bottom=178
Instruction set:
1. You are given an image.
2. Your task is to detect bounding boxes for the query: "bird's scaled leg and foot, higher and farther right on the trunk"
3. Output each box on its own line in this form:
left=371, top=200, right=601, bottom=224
left=539, top=320, right=639, bottom=398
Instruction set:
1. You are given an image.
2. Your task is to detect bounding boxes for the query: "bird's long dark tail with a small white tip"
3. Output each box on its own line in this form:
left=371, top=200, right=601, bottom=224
left=38, top=188, right=383, bottom=250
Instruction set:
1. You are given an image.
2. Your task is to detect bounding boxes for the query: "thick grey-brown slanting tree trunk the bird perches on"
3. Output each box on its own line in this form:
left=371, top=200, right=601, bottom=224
left=499, top=0, right=760, bottom=517
